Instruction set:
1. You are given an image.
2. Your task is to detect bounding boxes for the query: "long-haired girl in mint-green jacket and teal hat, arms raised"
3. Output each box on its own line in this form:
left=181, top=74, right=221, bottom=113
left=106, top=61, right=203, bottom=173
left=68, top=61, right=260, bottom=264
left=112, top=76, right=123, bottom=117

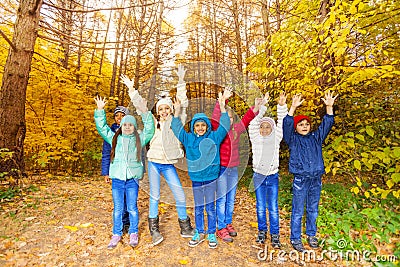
left=94, top=97, right=154, bottom=249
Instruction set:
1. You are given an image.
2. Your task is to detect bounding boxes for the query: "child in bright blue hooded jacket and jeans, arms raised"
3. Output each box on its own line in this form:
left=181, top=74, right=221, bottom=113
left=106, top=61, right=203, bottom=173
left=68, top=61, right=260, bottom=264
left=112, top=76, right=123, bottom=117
left=171, top=93, right=230, bottom=248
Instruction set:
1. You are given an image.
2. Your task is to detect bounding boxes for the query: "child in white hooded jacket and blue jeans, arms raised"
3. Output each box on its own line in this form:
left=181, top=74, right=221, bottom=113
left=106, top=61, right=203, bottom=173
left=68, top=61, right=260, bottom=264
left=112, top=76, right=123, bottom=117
left=249, top=92, right=288, bottom=248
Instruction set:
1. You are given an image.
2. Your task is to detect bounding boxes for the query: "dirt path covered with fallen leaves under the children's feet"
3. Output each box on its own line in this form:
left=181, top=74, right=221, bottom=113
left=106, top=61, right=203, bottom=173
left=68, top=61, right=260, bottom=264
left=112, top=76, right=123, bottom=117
left=0, top=174, right=382, bottom=266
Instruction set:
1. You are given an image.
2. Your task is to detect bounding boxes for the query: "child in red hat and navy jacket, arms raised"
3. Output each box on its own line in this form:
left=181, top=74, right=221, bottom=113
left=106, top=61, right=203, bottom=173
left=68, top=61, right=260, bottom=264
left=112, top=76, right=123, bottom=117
left=283, top=91, right=338, bottom=252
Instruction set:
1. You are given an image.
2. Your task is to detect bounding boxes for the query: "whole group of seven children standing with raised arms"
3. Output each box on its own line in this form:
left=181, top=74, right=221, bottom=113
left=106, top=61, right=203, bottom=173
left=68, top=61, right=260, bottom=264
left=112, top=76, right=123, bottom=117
left=95, top=66, right=337, bottom=252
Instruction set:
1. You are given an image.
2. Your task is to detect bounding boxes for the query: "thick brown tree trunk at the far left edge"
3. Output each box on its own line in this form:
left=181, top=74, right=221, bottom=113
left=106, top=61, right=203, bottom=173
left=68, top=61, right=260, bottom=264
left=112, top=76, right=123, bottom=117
left=0, top=0, right=43, bottom=177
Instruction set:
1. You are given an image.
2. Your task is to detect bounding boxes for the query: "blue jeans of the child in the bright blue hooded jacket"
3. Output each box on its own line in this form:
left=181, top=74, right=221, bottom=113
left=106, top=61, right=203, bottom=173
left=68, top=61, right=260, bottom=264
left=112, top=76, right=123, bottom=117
left=192, top=179, right=217, bottom=234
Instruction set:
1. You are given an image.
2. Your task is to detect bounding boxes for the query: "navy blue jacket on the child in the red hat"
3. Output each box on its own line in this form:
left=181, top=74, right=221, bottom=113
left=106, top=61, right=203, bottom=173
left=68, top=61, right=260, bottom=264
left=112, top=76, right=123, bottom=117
left=283, top=114, right=334, bottom=177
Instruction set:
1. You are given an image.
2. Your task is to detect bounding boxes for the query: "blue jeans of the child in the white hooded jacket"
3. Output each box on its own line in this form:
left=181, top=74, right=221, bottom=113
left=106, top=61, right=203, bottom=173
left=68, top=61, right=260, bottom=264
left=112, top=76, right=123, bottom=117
left=253, top=172, right=279, bottom=234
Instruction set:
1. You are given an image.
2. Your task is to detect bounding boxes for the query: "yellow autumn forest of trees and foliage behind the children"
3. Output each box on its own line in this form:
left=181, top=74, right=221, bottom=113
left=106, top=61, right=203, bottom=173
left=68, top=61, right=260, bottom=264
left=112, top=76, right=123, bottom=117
left=0, top=0, right=400, bottom=266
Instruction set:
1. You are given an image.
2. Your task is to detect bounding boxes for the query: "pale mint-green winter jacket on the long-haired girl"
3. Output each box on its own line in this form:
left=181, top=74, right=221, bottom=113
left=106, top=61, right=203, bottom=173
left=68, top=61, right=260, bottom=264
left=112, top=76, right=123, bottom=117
left=94, top=109, right=154, bottom=180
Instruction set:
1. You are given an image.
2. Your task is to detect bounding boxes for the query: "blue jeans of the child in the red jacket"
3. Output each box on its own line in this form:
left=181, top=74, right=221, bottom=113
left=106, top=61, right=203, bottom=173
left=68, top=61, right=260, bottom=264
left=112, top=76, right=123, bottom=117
left=216, top=166, right=238, bottom=230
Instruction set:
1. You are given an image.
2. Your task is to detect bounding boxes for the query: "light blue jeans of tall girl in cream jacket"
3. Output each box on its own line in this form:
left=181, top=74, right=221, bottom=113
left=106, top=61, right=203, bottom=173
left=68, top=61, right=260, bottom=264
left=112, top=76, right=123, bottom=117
left=147, top=161, right=187, bottom=220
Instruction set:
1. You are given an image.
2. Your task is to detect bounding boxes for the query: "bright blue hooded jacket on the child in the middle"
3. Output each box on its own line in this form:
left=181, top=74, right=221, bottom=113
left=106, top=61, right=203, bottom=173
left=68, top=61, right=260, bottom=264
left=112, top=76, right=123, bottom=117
left=171, top=112, right=230, bottom=182
